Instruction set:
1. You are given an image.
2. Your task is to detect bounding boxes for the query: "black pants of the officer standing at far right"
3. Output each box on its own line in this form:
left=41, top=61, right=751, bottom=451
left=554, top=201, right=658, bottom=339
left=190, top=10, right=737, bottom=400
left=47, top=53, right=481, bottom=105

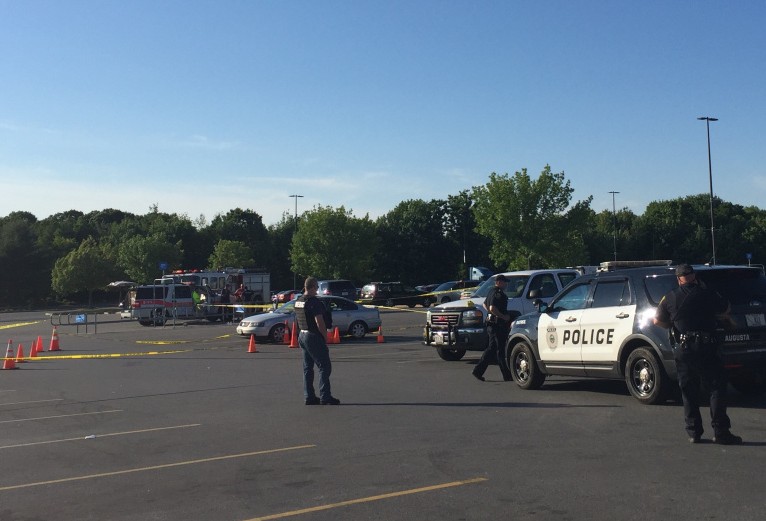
left=675, top=342, right=731, bottom=436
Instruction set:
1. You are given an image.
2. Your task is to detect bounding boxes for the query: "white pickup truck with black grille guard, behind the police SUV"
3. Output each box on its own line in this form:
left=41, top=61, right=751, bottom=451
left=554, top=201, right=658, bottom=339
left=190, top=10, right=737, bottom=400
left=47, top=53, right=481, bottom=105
left=423, top=269, right=580, bottom=362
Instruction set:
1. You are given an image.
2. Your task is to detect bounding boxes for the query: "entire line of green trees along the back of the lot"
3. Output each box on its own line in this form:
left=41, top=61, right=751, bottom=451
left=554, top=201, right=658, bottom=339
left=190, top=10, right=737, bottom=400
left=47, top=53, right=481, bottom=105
left=0, top=166, right=766, bottom=309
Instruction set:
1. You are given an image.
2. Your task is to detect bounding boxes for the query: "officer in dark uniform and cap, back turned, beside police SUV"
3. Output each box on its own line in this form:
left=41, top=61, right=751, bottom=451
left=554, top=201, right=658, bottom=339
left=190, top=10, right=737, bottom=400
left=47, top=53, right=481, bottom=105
left=654, top=264, right=742, bottom=445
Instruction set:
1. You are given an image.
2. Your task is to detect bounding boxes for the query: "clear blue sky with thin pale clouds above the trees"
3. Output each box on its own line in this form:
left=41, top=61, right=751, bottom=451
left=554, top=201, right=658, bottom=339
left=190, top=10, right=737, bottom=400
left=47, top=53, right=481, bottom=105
left=0, top=0, right=766, bottom=224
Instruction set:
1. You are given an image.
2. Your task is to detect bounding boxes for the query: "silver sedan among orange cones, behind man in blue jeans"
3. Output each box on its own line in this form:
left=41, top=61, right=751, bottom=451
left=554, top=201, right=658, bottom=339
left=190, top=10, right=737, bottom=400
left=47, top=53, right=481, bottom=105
left=237, top=295, right=380, bottom=342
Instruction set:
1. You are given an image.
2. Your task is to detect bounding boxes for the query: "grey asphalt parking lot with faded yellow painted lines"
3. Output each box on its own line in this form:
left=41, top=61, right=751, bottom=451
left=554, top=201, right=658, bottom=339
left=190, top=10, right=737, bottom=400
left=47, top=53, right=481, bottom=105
left=0, top=308, right=766, bottom=521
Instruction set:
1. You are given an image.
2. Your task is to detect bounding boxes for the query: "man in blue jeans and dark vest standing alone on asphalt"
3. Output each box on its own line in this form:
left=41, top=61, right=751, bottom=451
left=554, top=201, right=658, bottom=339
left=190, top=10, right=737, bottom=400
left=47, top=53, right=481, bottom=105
left=295, top=277, right=340, bottom=405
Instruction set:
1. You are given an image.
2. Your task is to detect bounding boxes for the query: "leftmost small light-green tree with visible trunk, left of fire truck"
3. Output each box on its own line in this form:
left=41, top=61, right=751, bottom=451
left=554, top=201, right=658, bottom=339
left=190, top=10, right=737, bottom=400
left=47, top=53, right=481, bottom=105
left=51, top=237, right=117, bottom=306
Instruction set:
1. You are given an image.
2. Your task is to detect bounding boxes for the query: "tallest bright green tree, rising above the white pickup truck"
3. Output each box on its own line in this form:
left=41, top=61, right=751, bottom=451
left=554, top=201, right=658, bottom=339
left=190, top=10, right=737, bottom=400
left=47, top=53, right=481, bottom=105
left=473, top=165, right=592, bottom=269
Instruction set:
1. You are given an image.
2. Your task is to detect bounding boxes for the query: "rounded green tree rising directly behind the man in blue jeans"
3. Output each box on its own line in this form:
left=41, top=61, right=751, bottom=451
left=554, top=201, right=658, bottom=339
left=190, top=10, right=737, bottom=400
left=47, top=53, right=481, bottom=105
left=290, top=206, right=375, bottom=282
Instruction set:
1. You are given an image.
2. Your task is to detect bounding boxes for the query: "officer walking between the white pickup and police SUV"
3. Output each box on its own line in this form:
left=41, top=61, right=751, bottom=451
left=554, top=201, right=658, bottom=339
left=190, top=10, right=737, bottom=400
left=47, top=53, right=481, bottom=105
left=471, top=273, right=512, bottom=382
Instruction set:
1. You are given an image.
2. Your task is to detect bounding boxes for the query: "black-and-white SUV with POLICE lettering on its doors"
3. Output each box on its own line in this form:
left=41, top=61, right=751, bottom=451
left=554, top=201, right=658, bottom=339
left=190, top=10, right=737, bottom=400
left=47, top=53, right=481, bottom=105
left=507, top=261, right=766, bottom=404
